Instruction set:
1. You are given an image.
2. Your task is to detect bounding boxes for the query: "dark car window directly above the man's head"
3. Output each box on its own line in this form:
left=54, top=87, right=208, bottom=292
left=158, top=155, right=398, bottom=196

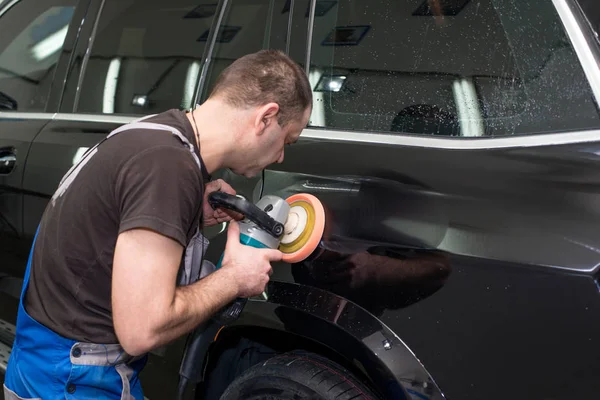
left=202, top=0, right=310, bottom=100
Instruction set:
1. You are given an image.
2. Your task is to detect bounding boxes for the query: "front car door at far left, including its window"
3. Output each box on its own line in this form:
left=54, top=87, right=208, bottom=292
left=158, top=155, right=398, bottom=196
left=0, top=0, right=88, bottom=295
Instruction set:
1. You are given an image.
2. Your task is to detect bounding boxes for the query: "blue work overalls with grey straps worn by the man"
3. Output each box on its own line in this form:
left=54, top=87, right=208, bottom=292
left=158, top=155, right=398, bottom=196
left=4, top=117, right=214, bottom=400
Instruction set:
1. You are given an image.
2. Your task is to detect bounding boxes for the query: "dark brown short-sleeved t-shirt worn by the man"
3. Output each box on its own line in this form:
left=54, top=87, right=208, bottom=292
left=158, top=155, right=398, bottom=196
left=25, top=110, right=209, bottom=344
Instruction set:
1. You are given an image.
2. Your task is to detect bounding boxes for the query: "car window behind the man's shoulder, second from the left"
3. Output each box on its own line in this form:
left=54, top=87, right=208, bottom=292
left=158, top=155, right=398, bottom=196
left=75, top=0, right=217, bottom=115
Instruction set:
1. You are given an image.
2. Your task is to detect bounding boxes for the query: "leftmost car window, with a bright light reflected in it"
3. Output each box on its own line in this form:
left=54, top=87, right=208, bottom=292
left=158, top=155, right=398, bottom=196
left=0, top=0, right=77, bottom=112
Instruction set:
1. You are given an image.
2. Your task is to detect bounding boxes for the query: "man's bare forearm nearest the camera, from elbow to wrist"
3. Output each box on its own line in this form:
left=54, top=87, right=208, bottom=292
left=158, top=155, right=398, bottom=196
left=145, top=269, right=237, bottom=354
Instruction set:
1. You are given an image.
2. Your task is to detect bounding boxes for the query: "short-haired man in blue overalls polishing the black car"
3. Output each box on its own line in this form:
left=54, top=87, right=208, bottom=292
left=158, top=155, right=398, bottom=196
left=4, top=51, right=312, bottom=399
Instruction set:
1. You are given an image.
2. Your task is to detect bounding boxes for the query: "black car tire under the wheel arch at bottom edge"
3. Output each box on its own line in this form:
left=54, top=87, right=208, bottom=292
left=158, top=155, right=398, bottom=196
left=221, top=351, right=378, bottom=400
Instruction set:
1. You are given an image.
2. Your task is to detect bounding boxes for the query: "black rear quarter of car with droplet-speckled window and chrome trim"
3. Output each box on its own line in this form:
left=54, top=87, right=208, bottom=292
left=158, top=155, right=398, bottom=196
left=264, top=0, right=600, bottom=400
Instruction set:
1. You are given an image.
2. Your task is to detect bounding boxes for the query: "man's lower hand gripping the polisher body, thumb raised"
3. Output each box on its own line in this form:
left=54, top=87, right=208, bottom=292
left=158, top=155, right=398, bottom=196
left=221, top=221, right=283, bottom=297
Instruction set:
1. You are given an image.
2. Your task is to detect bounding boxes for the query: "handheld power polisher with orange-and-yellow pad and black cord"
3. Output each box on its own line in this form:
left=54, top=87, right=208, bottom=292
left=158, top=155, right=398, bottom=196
left=179, top=192, right=325, bottom=398
